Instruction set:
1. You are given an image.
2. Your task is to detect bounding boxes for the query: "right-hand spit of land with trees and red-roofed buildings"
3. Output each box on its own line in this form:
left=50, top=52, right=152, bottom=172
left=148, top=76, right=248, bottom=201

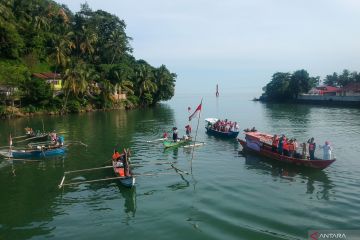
left=254, top=69, right=360, bottom=105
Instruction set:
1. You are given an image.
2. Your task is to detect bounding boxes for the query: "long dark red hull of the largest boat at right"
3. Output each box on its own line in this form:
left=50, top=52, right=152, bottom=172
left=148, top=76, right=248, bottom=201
left=238, top=139, right=336, bottom=169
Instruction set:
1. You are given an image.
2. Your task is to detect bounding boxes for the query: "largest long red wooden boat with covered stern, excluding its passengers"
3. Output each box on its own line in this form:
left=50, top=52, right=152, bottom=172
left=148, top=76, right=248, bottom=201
left=238, top=131, right=336, bottom=169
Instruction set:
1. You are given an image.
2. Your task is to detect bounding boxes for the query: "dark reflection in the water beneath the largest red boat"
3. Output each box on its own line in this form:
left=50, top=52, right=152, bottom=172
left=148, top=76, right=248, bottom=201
left=239, top=151, right=334, bottom=200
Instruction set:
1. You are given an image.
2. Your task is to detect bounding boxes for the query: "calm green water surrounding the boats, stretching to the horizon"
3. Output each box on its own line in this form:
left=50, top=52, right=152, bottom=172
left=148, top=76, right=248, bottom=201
left=0, top=94, right=360, bottom=239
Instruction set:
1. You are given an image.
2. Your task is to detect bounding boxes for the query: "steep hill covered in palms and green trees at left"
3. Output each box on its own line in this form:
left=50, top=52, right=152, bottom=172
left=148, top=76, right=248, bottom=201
left=0, top=0, right=176, bottom=115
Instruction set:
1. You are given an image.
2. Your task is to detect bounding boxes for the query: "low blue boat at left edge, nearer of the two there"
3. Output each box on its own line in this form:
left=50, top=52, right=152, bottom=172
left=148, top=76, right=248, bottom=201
left=0, top=146, right=65, bottom=158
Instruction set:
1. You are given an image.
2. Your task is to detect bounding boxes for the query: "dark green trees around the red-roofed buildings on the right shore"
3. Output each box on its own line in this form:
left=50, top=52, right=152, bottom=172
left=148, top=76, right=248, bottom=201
left=261, top=69, right=360, bottom=101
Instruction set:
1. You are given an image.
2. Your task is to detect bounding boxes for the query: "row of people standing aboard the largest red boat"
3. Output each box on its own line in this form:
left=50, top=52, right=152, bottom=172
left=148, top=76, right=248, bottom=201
left=271, top=134, right=332, bottom=160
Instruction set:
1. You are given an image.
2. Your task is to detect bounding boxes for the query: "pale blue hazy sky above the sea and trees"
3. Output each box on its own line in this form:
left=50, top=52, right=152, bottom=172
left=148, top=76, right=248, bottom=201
left=56, top=0, right=360, bottom=95
